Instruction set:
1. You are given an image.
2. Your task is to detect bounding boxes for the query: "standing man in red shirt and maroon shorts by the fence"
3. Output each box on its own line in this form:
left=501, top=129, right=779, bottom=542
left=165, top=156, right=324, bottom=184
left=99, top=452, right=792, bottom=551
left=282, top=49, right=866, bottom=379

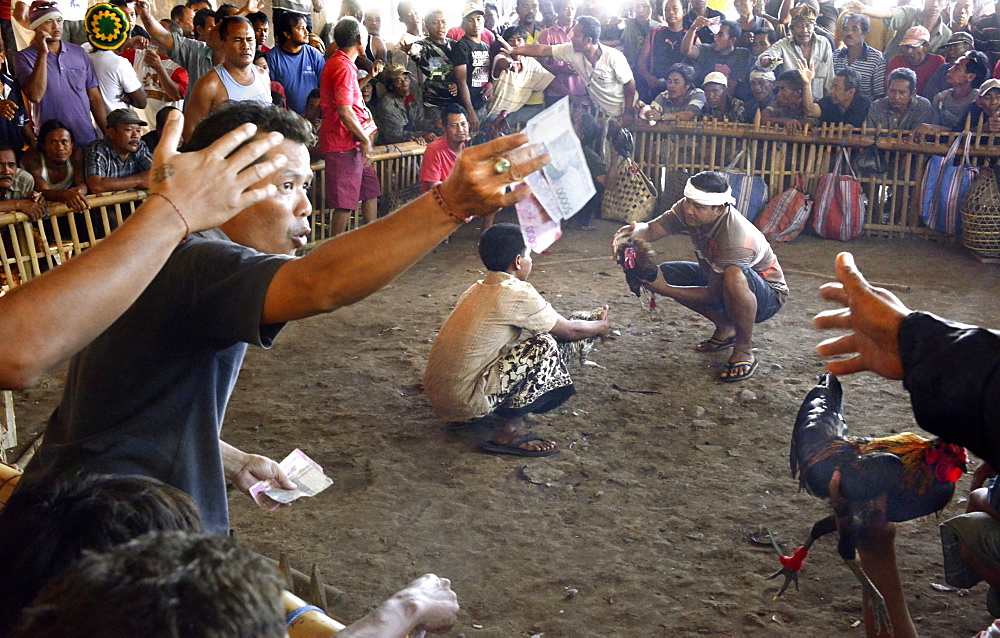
left=319, top=16, right=382, bottom=234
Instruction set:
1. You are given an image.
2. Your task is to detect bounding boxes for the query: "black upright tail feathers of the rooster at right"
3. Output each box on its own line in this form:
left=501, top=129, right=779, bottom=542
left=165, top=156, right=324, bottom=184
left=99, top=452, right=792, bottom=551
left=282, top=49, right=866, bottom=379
left=788, top=372, right=847, bottom=487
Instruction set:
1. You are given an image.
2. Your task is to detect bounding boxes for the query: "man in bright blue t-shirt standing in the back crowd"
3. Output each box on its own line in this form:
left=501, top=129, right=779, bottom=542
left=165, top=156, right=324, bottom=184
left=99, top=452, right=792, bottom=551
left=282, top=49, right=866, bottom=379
left=267, top=13, right=326, bottom=115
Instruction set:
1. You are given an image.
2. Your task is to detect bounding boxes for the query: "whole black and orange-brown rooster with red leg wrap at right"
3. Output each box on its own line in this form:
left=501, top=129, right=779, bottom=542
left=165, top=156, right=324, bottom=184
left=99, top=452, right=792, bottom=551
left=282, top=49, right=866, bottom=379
left=768, top=374, right=968, bottom=630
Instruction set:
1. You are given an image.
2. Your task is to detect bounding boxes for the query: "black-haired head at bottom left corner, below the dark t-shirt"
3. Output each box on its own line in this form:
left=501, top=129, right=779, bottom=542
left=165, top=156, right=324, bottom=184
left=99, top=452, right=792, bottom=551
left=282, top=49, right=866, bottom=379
left=0, top=474, right=202, bottom=635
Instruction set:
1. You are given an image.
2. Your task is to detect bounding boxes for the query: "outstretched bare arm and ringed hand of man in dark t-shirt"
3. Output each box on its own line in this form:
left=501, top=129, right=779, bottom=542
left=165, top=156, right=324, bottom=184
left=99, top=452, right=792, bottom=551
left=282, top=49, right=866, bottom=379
left=261, top=135, right=549, bottom=325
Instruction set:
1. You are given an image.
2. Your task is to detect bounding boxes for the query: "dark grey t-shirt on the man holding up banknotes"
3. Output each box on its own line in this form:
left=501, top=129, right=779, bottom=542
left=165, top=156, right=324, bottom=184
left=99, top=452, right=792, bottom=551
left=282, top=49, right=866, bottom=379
left=23, top=229, right=290, bottom=534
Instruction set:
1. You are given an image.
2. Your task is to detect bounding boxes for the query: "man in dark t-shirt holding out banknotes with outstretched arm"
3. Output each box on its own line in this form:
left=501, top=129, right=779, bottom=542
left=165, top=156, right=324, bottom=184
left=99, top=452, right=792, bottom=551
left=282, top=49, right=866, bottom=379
left=15, top=101, right=548, bottom=533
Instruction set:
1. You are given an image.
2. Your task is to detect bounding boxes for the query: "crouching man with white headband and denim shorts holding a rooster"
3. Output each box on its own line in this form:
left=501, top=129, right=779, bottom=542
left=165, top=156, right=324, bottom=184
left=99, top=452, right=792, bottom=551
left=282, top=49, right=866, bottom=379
left=613, top=171, right=788, bottom=382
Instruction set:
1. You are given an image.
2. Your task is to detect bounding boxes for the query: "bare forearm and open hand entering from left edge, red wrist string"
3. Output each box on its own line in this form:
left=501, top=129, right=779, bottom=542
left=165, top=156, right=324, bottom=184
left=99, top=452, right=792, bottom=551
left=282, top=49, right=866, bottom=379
left=0, top=113, right=285, bottom=389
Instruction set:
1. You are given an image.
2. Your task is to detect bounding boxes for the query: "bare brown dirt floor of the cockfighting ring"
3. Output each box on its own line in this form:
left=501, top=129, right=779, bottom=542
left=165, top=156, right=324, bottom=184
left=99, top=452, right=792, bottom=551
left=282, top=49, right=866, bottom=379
left=11, top=221, right=1000, bottom=638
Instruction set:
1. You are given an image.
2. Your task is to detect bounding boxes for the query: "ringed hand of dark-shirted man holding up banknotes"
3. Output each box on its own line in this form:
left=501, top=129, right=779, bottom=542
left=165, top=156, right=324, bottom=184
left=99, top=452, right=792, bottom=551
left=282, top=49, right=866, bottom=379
left=440, top=134, right=550, bottom=217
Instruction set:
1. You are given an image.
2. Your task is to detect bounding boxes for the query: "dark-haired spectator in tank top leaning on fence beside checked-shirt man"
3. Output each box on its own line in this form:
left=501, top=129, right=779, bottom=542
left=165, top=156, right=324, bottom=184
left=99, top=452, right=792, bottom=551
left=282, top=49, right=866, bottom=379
left=23, top=120, right=90, bottom=212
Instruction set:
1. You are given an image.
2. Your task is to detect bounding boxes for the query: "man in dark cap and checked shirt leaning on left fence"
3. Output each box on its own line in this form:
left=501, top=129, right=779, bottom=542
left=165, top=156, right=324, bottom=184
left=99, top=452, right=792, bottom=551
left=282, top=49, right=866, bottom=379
left=84, top=109, right=153, bottom=193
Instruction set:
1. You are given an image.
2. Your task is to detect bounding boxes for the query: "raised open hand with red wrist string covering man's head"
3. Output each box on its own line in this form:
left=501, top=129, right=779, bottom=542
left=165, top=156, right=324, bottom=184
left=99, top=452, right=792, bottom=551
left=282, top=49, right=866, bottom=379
left=149, top=111, right=287, bottom=232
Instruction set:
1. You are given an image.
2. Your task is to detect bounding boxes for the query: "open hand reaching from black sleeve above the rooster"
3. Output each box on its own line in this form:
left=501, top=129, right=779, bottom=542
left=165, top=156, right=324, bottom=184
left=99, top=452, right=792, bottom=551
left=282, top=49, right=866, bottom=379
left=813, top=253, right=910, bottom=379
